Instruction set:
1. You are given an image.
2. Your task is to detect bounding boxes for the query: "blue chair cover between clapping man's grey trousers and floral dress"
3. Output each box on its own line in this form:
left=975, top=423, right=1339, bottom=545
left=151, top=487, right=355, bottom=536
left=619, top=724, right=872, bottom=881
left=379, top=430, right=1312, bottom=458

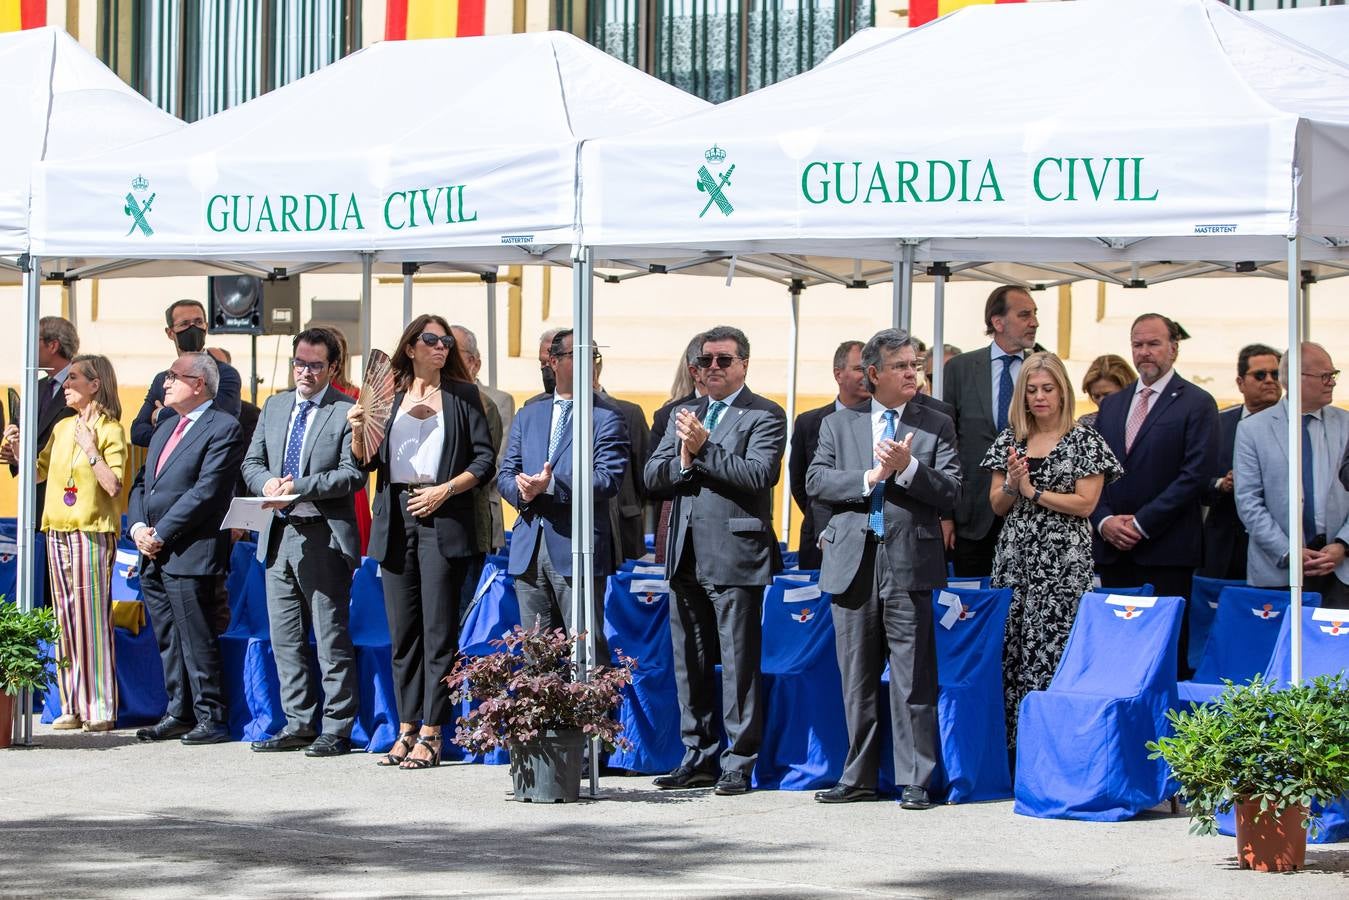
left=932, top=587, right=1012, bottom=803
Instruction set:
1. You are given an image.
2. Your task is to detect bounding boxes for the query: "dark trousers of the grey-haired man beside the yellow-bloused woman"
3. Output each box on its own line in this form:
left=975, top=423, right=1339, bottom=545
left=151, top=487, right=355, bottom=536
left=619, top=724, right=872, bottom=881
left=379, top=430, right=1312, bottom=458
left=140, top=563, right=229, bottom=725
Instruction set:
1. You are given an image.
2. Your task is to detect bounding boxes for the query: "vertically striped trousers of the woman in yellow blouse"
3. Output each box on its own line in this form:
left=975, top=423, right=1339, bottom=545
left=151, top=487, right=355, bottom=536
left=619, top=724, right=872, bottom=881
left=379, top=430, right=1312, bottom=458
left=47, top=532, right=117, bottom=722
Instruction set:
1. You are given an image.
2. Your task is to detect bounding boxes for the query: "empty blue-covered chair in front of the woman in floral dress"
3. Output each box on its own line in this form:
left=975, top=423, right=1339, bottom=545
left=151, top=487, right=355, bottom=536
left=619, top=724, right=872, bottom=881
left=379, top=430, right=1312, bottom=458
left=1013, top=592, right=1184, bottom=822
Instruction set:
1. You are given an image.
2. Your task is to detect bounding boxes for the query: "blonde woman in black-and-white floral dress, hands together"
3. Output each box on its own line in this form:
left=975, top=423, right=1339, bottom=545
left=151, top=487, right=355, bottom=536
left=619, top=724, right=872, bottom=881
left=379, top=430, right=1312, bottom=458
left=982, top=354, right=1124, bottom=750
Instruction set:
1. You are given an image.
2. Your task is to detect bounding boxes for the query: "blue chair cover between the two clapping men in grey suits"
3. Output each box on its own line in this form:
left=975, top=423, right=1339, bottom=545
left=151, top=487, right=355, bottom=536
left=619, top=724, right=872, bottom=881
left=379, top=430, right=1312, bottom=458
left=754, top=572, right=847, bottom=791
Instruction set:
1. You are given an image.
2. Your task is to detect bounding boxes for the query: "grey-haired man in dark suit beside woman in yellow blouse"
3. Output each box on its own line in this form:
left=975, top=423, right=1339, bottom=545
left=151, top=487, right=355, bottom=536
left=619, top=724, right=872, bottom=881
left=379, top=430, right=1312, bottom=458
left=127, top=352, right=244, bottom=745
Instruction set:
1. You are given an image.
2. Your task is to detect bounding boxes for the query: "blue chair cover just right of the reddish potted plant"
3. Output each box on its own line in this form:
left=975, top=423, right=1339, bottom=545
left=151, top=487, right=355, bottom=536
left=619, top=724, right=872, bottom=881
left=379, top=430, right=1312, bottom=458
left=604, top=567, right=684, bottom=775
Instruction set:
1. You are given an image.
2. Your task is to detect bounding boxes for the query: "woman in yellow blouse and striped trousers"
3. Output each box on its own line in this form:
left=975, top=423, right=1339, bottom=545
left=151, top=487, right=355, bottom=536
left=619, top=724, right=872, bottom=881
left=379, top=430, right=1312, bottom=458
left=5, top=355, right=127, bottom=731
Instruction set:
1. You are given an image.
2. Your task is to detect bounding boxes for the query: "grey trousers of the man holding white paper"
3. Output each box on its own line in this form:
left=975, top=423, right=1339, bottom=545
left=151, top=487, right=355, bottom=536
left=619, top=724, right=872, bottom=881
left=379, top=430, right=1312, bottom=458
left=267, top=522, right=360, bottom=738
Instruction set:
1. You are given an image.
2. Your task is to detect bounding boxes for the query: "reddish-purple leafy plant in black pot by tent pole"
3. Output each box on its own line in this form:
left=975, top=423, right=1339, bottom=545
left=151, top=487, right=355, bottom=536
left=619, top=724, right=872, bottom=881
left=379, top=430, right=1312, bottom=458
left=445, top=625, right=637, bottom=803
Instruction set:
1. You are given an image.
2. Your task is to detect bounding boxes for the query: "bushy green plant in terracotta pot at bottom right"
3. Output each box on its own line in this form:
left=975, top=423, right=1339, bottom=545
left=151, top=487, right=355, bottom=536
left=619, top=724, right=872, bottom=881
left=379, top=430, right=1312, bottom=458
left=1148, top=675, right=1349, bottom=872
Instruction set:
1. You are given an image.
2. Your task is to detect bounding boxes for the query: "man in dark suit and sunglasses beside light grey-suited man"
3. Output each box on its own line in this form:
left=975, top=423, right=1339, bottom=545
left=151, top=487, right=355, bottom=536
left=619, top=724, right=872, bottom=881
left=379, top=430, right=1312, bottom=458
left=1199, top=344, right=1282, bottom=582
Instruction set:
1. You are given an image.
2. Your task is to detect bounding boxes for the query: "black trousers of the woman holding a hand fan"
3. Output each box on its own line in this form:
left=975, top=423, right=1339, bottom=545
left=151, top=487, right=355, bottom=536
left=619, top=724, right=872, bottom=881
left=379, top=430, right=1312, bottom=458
left=379, top=488, right=469, bottom=726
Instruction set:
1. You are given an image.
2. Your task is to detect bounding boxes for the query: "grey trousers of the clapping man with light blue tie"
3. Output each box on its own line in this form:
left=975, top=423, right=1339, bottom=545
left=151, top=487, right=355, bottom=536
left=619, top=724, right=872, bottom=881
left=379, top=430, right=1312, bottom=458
left=832, top=545, right=938, bottom=789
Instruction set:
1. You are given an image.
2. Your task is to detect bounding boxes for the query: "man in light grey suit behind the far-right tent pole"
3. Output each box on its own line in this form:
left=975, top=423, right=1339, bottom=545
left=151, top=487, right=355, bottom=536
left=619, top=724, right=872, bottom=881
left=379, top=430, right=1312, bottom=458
left=1232, top=341, right=1349, bottom=609
